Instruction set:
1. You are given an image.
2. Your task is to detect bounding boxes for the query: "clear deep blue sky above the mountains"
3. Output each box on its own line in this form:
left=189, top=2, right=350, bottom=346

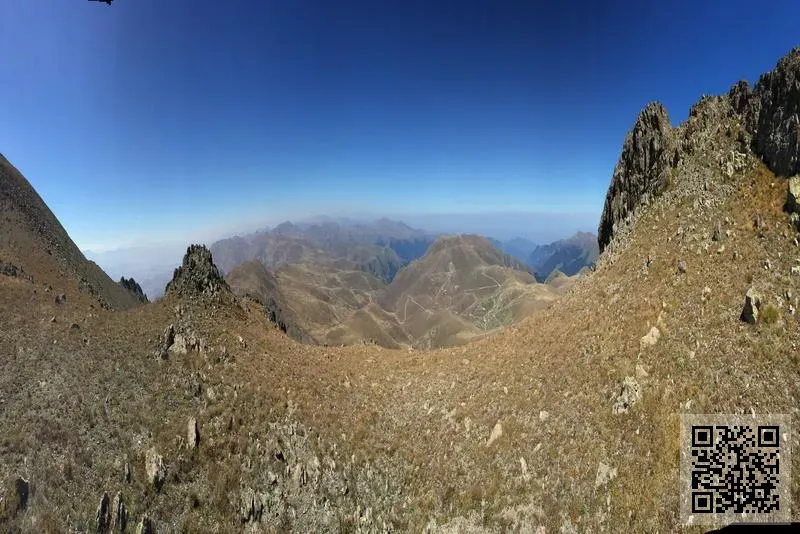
left=0, top=0, right=800, bottom=251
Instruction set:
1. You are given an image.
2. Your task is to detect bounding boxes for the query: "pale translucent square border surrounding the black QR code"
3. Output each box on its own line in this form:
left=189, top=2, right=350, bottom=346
left=680, top=414, right=792, bottom=527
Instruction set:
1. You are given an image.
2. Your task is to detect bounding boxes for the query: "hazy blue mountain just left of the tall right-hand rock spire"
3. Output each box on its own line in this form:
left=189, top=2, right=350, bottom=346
left=528, top=232, right=600, bottom=280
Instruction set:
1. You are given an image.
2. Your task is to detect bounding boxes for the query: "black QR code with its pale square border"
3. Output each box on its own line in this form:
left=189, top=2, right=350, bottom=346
left=681, top=414, right=791, bottom=525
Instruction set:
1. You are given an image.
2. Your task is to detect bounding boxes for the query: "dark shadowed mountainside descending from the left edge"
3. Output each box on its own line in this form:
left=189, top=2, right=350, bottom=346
left=0, top=155, right=142, bottom=309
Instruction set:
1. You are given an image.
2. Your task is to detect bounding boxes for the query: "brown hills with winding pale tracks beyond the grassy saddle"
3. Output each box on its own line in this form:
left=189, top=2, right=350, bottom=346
left=225, top=231, right=570, bottom=349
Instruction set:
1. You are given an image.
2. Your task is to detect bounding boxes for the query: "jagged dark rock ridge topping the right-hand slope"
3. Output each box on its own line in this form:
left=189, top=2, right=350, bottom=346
left=598, top=47, right=800, bottom=252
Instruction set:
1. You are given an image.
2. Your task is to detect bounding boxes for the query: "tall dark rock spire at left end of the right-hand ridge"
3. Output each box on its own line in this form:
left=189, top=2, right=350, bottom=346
left=597, top=102, right=676, bottom=252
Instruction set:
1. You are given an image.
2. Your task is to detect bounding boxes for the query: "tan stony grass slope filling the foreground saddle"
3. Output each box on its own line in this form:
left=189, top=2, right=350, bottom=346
left=0, top=159, right=800, bottom=532
